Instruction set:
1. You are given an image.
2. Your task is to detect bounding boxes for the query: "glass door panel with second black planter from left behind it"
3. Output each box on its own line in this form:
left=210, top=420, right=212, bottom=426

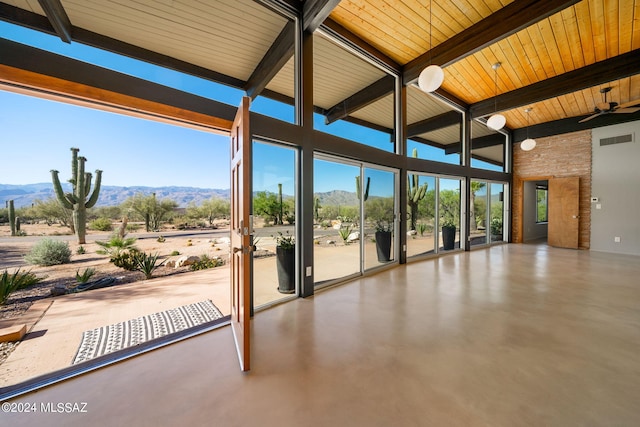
left=358, top=167, right=396, bottom=270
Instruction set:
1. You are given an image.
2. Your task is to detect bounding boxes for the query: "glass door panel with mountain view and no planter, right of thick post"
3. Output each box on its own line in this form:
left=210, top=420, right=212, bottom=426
left=313, top=158, right=361, bottom=286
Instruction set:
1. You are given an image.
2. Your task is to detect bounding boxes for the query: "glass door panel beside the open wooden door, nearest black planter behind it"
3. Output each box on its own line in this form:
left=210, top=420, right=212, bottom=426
left=252, top=141, right=297, bottom=307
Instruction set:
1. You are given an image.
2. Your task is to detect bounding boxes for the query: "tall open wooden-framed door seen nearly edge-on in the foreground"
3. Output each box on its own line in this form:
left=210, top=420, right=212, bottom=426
left=230, top=97, right=253, bottom=371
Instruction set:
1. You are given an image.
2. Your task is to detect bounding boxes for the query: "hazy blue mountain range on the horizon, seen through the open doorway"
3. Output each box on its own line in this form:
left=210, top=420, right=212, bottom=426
left=0, top=183, right=229, bottom=208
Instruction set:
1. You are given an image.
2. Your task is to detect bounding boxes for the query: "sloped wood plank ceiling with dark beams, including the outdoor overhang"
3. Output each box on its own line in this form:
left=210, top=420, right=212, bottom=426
left=0, top=0, right=640, bottom=140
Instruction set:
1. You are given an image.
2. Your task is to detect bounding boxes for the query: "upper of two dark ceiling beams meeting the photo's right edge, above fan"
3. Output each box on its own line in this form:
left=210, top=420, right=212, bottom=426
left=469, top=49, right=640, bottom=118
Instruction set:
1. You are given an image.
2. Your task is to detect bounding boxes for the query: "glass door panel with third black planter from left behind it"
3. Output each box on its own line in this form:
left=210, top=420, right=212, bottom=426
left=438, top=178, right=462, bottom=252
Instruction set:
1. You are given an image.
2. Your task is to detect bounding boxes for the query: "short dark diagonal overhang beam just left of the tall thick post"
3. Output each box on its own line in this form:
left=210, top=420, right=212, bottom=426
left=245, top=21, right=296, bottom=99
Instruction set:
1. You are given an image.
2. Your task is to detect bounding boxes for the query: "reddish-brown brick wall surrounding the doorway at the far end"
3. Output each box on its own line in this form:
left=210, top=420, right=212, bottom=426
left=511, top=130, right=591, bottom=249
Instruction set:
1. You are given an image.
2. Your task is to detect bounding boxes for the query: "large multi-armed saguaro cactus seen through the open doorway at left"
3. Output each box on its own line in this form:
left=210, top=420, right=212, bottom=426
left=51, top=148, right=102, bottom=244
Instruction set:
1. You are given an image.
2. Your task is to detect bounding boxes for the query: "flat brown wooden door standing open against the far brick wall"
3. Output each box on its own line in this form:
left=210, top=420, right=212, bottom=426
left=547, top=177, right=580, bottom=249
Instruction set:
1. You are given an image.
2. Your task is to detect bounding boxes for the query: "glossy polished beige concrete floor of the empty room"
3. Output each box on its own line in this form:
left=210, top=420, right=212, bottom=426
left=0, top=244, right=640, bottom=426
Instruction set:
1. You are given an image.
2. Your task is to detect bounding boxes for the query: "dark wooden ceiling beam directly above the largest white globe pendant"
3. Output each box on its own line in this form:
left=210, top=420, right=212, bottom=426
left=403, top=0, right=580, bottom=84
